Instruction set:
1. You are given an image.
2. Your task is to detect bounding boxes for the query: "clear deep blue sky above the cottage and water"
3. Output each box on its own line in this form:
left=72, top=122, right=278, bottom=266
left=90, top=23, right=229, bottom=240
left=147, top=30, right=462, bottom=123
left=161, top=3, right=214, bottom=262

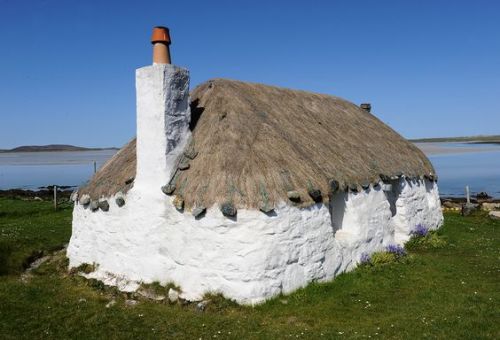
left=0, top=0, right=500, bottom=148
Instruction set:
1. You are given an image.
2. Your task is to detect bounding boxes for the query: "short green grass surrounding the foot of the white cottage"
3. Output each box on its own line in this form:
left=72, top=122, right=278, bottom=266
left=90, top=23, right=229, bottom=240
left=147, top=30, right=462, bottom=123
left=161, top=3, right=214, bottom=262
left=0, top=200, right=500, bottom=339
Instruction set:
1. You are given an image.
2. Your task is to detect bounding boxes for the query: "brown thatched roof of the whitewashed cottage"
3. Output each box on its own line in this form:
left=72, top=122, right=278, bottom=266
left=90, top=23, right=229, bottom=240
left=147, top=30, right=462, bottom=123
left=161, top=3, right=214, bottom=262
left=80, top=79, right=434, bottom=208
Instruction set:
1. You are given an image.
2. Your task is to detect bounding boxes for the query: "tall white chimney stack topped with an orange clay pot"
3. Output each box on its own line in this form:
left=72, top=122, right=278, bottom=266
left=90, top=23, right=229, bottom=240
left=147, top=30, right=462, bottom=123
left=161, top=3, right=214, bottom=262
left=134, top=27, right=191, bottom=191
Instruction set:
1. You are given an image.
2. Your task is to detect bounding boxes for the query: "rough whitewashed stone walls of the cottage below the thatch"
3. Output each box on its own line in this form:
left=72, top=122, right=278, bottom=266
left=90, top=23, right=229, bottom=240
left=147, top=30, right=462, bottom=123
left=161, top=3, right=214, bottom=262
left=67, top=179, right=443, bottom=304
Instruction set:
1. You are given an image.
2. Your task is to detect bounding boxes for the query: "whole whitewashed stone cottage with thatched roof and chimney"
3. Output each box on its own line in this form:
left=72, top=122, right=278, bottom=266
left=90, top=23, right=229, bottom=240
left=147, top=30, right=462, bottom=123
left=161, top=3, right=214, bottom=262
left=68, top=26, right=443, bottom=303
